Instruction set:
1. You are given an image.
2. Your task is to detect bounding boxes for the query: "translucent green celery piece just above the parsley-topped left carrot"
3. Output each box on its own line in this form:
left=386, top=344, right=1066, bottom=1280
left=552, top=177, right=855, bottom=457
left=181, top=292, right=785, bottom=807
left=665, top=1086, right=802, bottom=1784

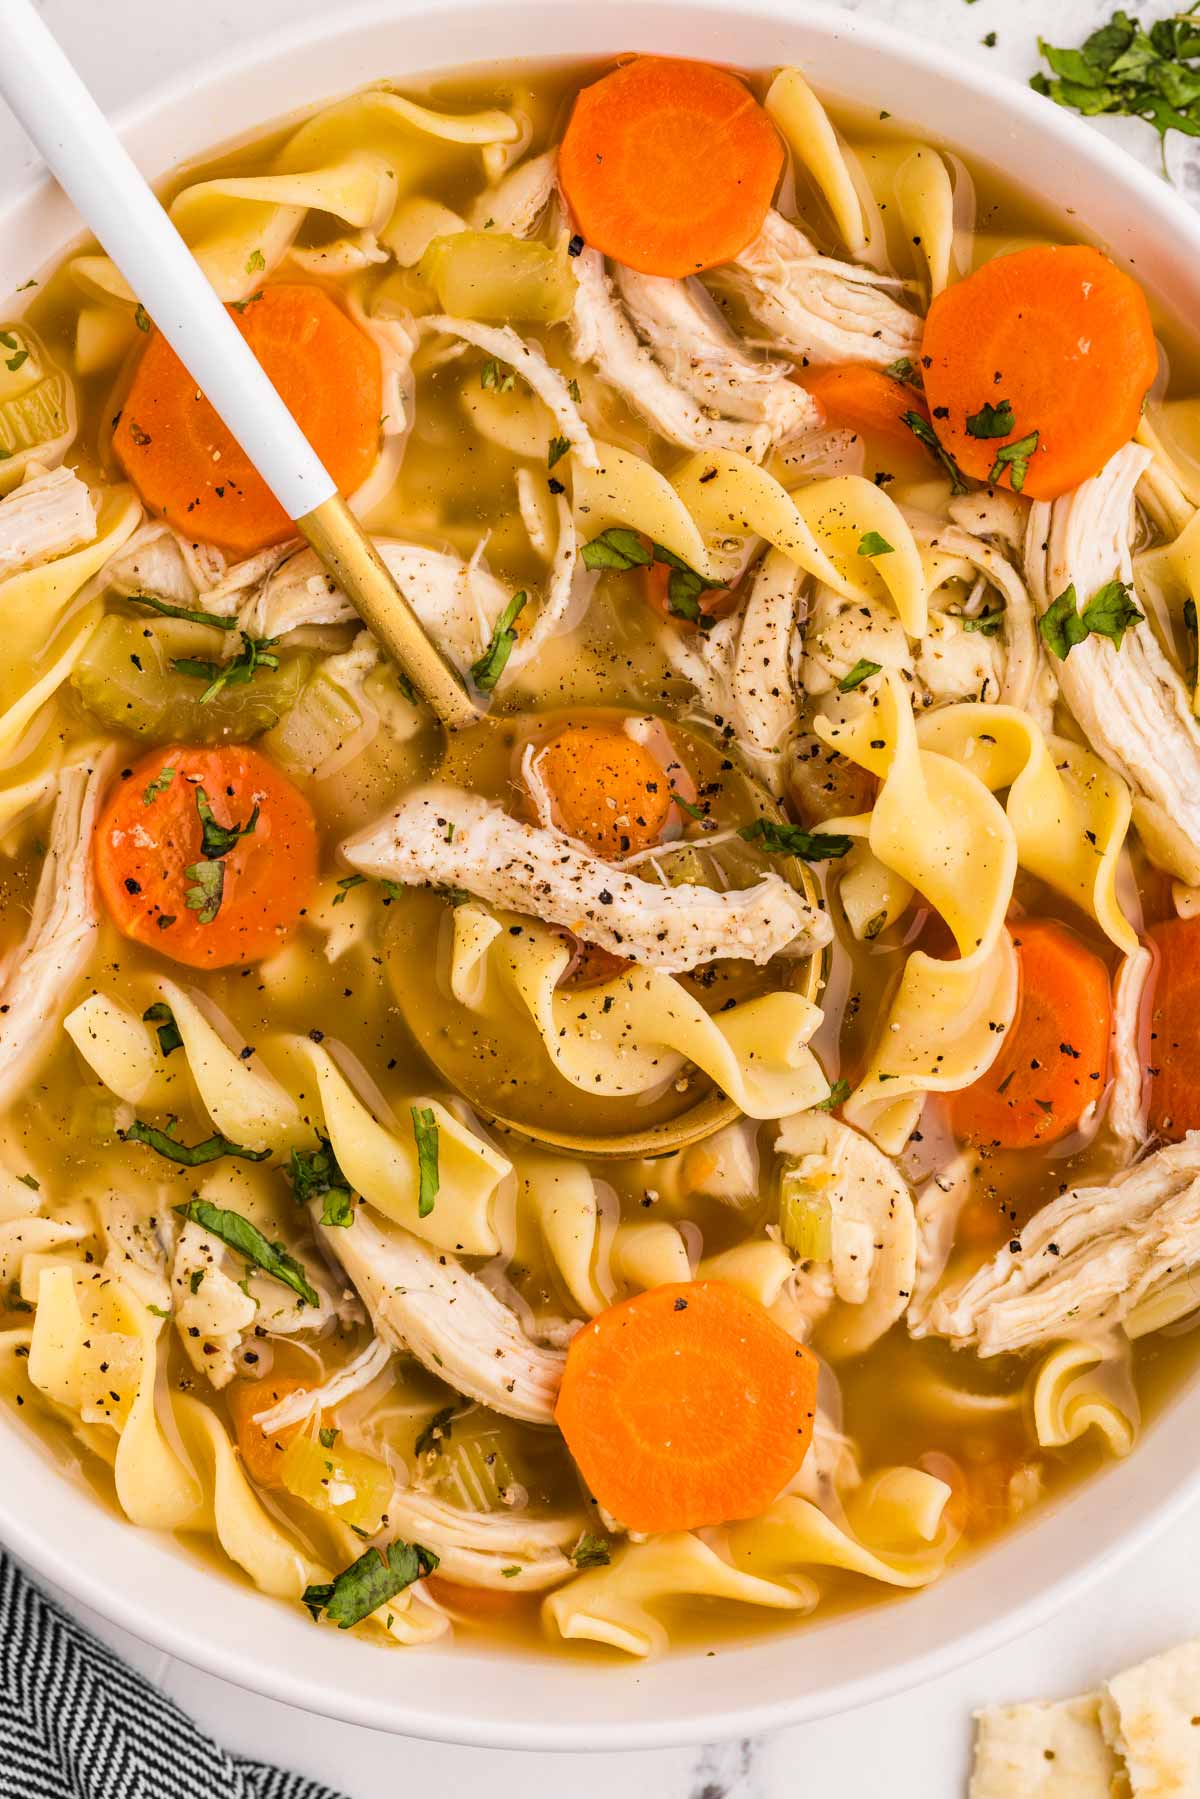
left=70, top=613, right=311, bottom=743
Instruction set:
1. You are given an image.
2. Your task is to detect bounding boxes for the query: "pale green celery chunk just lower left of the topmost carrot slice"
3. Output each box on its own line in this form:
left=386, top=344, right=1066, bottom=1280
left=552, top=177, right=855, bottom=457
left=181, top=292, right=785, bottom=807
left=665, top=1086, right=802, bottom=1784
left=419, top=230, right=576, bottom=326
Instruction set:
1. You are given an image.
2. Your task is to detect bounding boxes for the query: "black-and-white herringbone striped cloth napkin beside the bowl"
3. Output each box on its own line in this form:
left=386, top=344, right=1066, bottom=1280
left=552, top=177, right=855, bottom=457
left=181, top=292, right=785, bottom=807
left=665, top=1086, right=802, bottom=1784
left=0, top=1554, right=347, bottom=1799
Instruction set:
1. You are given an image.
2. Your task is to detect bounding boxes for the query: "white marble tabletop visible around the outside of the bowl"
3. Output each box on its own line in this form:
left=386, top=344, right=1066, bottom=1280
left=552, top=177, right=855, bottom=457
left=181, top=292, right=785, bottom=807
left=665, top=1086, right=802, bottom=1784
left=9, top=0, right=1200, bottom=1799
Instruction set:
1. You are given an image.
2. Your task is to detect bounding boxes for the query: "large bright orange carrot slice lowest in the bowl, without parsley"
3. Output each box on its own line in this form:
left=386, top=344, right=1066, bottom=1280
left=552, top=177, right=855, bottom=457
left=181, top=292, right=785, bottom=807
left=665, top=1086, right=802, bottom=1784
left=554, top=1281, right=817, bottom=1531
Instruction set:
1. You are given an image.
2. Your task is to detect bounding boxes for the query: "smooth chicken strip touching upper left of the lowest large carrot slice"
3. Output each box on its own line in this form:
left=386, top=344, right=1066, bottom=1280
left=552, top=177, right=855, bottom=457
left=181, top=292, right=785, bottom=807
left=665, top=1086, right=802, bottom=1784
left=318, top=1205, right=565, bottom=1425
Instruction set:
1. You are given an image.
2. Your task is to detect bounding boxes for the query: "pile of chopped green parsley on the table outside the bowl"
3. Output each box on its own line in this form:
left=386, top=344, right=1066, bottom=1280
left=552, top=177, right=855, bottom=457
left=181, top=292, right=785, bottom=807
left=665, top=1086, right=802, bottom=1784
left=1029, top=7, right=1200, bottom=169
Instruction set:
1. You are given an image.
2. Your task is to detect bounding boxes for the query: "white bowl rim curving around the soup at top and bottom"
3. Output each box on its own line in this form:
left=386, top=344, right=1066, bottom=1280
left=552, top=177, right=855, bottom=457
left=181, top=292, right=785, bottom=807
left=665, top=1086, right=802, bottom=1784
left=0, top=0, right=1200, bottom=1750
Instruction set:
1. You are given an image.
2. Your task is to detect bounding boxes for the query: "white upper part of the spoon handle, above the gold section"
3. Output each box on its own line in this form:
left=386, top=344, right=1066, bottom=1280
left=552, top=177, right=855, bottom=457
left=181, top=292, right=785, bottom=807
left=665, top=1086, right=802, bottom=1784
left=0, top=0, right=336, bottom=518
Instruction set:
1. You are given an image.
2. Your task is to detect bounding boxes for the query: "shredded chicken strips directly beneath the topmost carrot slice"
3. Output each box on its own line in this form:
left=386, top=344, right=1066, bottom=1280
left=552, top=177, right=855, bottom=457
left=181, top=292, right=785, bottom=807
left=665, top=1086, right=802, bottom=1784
left=570, top=250, right=819, bottom=461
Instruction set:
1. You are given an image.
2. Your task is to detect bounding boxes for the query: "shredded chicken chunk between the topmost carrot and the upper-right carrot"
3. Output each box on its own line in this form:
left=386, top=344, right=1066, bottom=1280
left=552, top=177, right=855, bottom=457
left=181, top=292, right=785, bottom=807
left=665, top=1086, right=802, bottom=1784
left=709, top=212, right=921, bottom=369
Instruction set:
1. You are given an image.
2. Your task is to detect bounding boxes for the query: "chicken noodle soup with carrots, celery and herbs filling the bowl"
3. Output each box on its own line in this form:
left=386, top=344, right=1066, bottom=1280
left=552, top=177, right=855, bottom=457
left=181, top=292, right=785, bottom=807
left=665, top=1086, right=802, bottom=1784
left=0, top=56, right=1200, bottom=1657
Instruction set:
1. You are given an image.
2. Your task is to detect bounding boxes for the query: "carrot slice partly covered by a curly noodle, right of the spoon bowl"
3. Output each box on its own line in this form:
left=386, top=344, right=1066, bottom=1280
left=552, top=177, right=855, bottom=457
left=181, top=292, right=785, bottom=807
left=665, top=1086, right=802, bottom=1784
left=950, top=919, right=1112, bottom=1150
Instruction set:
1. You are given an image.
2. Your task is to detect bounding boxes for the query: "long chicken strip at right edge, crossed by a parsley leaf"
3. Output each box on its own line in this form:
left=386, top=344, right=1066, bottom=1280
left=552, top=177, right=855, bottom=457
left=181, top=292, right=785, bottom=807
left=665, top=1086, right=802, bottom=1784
left=1025, top=444, right=1200, bottom=883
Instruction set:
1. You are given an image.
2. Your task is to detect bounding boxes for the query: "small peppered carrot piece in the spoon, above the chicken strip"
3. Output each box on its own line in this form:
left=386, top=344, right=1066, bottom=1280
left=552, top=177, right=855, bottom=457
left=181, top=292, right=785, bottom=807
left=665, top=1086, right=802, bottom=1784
left=538, top=725, right=671, bottom=856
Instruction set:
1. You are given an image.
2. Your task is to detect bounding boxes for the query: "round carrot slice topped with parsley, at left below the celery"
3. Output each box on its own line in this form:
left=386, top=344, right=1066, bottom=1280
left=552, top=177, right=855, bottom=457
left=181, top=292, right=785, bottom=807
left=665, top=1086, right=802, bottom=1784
left=95, top=745, right=317, bottom=968
